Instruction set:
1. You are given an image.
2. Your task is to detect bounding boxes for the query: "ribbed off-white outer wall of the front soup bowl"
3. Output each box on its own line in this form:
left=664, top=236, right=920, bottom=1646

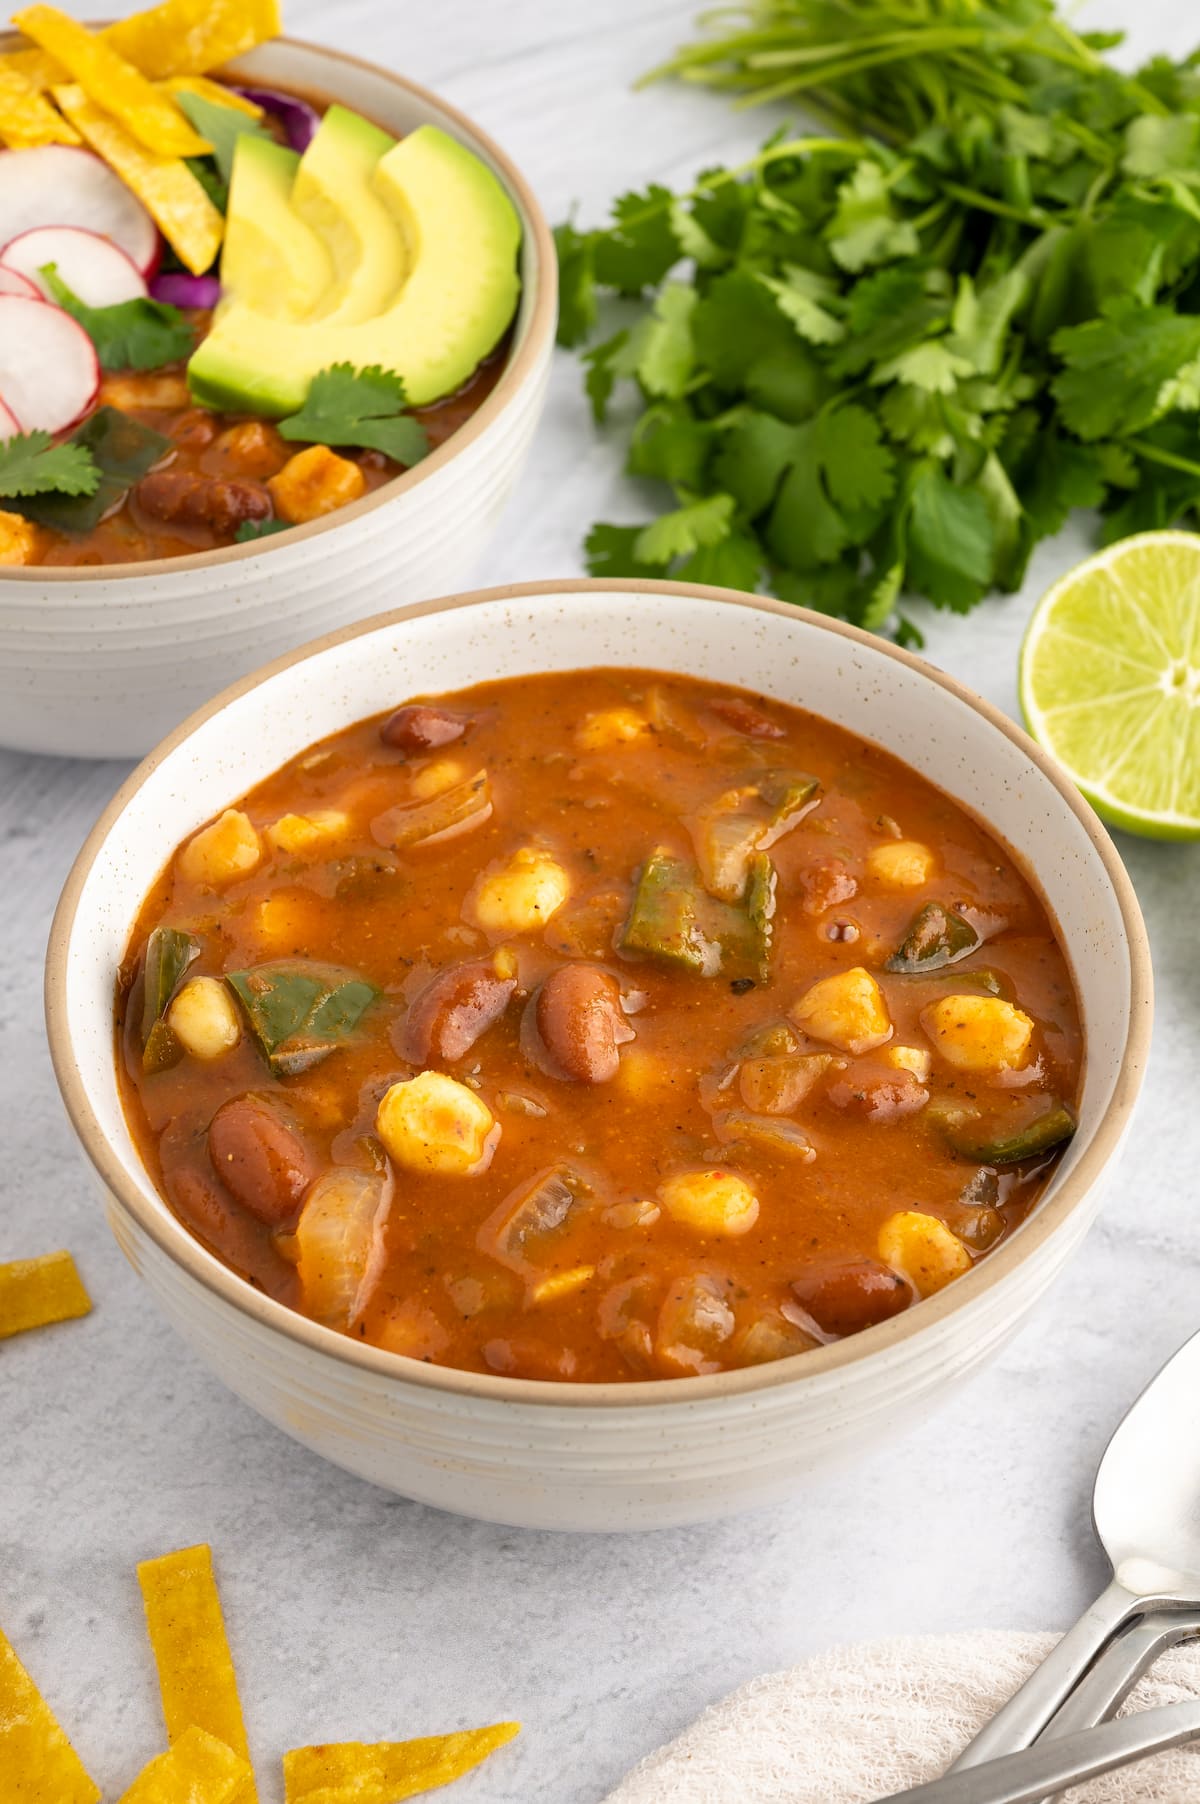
left=100, top=1161, right=1101, bottom=1533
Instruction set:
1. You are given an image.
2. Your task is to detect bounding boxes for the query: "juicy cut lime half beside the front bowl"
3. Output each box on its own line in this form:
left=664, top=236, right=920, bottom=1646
left=1020, top=532, right=1200, bottom=839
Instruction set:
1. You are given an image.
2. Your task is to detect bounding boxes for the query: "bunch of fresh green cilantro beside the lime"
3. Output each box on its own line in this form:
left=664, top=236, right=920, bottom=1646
left=556, top=0, right=1200, bottom=642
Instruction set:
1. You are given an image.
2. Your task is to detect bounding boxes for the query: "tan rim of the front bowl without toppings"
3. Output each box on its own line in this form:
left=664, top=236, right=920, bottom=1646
left=45, top=577, right=1153, bottom=1409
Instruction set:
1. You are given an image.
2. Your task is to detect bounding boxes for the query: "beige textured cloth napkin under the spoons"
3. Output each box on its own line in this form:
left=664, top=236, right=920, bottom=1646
left=606, top=1633, right=1200, bottom=1804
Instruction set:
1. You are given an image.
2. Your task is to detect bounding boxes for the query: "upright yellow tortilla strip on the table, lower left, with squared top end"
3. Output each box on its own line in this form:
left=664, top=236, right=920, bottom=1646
left=137, top=1546, right=258, bottom=1804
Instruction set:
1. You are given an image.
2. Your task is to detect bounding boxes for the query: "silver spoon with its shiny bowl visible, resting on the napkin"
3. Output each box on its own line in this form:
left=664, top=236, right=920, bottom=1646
left=949, top=1335, right=1200, bottom=1767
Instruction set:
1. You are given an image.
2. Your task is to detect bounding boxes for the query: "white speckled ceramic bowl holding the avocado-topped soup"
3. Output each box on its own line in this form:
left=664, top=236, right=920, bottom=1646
left=0, top=34, right=558, bottom=758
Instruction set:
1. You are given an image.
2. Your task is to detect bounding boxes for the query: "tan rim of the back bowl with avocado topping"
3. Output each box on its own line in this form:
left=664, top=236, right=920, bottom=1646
left=0, top=31, right=558, bottom=584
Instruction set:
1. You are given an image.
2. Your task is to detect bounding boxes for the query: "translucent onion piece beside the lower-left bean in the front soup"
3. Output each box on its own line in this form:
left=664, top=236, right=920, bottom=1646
left=292, top=1165, right=392, bottom=1333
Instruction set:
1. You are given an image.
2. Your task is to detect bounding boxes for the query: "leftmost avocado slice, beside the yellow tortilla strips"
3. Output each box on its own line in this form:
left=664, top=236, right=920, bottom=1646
left=220, top=132, right=334, bottom=319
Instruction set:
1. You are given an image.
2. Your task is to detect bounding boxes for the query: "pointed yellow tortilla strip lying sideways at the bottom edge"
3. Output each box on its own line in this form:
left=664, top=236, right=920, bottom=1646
left=283, top=1723, right=522, bottom=1804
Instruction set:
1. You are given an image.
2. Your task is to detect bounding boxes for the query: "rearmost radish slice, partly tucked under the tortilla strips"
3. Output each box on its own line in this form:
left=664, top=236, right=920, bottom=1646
left=0, top=144, right=161, bottom=278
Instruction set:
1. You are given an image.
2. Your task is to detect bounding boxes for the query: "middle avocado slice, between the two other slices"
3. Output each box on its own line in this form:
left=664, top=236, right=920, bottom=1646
left=292, top=106, right=408, bottom=325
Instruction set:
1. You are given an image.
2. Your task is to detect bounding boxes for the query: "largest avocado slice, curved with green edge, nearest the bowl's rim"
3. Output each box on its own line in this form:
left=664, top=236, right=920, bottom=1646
left=188, top=124, right=522, bottom=417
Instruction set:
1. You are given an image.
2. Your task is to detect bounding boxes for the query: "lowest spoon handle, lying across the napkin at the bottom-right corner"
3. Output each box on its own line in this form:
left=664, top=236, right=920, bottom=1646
left=879, top=1699, right=1200, bottom=1804
